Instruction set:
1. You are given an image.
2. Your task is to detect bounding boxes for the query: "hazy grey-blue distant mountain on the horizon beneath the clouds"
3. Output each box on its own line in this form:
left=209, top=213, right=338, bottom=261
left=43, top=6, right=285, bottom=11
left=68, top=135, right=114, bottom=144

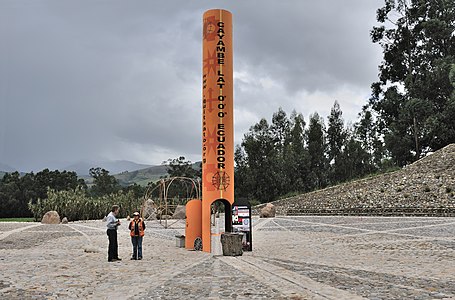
left=62, top=160, right=153, bottom=177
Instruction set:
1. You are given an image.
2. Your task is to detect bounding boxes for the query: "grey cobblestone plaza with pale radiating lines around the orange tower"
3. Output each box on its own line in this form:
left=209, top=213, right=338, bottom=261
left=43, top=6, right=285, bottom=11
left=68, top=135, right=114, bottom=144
left=0, top=216, right=455, bottom=299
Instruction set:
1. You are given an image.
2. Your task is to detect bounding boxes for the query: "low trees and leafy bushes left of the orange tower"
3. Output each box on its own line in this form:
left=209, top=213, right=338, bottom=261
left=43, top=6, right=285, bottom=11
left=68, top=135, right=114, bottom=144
left=0, top=156, right=200, bottom=221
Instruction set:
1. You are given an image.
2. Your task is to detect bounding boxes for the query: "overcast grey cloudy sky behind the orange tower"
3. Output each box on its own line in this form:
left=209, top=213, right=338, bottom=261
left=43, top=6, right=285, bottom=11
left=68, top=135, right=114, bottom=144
left=0, top=0, right=383, bottom=171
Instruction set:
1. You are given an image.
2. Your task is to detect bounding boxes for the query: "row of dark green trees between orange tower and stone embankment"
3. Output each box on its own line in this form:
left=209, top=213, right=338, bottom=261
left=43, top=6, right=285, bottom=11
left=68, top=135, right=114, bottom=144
left=234, top=101, right=393, bottom=202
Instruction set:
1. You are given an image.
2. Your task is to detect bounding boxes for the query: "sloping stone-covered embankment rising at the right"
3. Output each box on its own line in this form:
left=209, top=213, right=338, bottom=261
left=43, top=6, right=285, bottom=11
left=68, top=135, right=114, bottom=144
left=253, top=144, right=455, bottom=216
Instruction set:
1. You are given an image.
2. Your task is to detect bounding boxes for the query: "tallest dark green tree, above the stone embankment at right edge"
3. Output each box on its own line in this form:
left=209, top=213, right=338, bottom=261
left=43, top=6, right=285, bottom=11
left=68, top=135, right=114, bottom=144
left=370, top=0, right=455, bottom=165
